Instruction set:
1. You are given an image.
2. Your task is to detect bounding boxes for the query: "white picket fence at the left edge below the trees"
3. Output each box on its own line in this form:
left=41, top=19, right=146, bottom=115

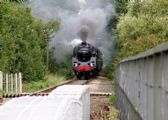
left=0, top=71, right=22, bottom=93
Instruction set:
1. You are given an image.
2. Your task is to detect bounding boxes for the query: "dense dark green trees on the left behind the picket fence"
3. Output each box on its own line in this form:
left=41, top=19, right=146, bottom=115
left=0, top=2, right=58, bottom=81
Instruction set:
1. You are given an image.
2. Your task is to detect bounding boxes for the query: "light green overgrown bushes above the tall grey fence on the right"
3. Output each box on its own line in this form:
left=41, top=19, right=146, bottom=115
left=107, top=0, right=168, bottom=79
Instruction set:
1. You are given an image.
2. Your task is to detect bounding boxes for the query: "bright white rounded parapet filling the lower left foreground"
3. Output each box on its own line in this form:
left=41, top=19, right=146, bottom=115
left=0, top=85, right=90, bottom=120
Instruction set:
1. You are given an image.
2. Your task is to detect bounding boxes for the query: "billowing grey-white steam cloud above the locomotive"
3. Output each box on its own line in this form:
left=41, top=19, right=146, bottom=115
left=28, top=0, right=115, bottom=61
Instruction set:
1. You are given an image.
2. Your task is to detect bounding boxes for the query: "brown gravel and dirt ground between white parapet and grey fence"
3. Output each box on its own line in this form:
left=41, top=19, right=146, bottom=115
left=88, top=77, right=118, bottom=120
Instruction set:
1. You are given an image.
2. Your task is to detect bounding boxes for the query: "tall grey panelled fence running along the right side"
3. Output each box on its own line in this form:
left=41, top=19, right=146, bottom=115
left=116, top=43, right=168, bottom=120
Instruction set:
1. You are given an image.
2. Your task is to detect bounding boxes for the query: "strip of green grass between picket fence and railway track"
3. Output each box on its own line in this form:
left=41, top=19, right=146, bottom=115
left=23, top=74, right=66, bottom=92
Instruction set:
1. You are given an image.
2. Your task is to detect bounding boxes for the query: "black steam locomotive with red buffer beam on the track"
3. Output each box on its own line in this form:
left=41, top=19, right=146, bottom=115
left=72, top=42, right=103, bottom=80
